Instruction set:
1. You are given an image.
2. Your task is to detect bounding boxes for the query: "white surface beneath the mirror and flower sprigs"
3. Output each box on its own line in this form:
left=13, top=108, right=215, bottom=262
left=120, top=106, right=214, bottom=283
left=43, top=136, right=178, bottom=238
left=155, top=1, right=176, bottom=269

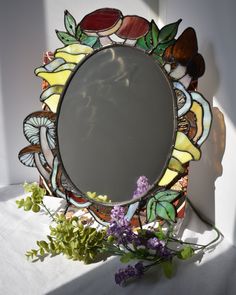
left=0, top=185, right=236, bottom=295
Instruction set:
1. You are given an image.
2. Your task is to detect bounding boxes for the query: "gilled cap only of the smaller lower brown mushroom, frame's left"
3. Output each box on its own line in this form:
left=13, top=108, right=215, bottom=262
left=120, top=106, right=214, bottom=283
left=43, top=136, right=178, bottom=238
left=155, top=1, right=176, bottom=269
left=18, top=145, right=46, bottom=167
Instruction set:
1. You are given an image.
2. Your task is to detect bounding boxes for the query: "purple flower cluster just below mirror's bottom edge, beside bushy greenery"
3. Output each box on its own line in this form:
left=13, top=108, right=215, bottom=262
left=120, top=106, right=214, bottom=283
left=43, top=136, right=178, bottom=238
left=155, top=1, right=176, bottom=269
left=107, top=206, right=139, bottom=245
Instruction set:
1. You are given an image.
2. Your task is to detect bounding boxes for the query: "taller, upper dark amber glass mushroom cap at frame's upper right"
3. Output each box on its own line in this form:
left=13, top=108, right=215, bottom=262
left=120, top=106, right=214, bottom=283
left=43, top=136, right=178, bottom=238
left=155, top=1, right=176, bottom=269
left=172, top=28, right=198, bottom=65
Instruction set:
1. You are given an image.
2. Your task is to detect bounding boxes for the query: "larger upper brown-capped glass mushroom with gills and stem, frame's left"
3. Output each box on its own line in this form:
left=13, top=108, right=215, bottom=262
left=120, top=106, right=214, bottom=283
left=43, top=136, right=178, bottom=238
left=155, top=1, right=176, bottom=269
left=23, top=111, right=55, bottom=167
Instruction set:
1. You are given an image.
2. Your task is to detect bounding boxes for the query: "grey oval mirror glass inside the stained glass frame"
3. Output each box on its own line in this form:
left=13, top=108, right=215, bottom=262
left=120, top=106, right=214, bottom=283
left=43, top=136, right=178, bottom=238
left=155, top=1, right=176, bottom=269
left=57, top=46, right=176, bottom=202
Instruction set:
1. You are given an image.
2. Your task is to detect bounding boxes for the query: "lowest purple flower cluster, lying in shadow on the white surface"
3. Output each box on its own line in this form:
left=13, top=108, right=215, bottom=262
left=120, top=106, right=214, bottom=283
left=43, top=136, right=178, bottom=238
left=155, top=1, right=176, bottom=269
left=115, top=262, right=145, bottom=285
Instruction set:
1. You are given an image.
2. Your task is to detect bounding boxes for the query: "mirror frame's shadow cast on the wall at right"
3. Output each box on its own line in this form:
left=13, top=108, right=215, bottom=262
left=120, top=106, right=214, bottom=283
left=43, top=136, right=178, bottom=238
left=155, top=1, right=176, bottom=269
left=188, top=44, right=226, bottom=227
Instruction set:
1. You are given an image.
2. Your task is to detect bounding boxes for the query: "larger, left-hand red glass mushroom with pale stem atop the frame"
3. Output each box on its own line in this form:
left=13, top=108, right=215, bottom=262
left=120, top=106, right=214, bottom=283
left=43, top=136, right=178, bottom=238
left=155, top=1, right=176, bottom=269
left=80, top=8, right=122, bottom=46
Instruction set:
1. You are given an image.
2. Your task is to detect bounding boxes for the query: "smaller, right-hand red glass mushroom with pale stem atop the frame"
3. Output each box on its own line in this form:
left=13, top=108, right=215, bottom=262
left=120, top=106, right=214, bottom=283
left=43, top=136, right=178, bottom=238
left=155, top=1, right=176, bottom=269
left=115, top=15, right=149, bottom=46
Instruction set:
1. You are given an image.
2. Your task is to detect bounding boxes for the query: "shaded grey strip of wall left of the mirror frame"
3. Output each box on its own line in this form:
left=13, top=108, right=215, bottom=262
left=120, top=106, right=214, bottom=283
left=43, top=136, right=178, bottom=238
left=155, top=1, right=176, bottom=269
left=0, top=0, right=46, bottom=183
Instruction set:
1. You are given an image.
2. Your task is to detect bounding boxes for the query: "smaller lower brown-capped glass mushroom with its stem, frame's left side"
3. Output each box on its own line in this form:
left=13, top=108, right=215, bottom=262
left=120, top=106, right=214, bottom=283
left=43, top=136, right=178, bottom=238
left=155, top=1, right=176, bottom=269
left=18, top=145, right=49, bottom=180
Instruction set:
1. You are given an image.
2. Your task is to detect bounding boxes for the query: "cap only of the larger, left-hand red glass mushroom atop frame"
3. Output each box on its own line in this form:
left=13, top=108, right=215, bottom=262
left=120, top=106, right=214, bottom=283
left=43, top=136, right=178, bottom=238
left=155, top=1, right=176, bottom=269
left=80, top=8, right=122, bottom=33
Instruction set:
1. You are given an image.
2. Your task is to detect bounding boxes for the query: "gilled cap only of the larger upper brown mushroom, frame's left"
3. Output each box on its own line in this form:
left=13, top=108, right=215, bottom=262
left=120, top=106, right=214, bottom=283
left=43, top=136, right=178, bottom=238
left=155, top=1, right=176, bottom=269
left=23, top=111, right=56, bottom=149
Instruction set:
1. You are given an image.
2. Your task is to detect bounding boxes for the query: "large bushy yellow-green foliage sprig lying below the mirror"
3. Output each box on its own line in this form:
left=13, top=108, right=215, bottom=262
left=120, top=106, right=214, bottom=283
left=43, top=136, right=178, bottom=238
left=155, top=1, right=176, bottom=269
left=26, top=215, right=106, bottom=264
